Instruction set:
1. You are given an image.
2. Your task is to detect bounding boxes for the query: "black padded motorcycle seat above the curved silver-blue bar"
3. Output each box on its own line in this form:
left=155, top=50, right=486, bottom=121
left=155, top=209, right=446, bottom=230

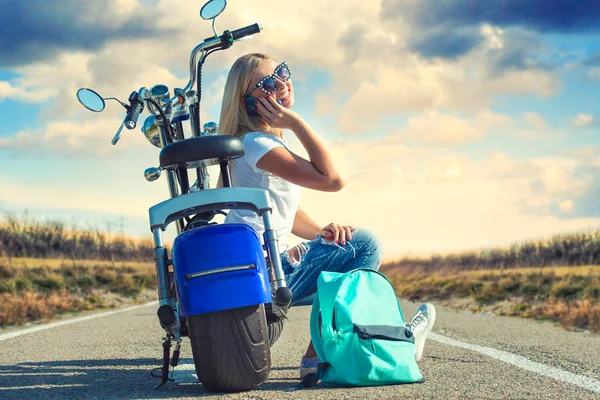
left=159, top=135, right=244, bottom=168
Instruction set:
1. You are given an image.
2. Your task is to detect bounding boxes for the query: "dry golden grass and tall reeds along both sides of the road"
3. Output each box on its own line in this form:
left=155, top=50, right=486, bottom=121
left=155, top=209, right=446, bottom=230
left=0, top=216, right=600, bottom=332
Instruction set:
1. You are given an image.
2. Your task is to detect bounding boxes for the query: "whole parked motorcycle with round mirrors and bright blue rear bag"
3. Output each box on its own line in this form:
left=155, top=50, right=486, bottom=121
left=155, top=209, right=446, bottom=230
left=77, top=0, right=292, bottom=392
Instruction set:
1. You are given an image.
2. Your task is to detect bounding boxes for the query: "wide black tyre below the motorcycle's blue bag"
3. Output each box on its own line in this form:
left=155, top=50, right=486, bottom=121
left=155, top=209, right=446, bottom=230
left=187, top=304, right=271, bottom=393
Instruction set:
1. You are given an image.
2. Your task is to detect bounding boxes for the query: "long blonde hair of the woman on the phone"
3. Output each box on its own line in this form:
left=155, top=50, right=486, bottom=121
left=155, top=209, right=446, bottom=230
left=217, top=53, right=273, bottom=188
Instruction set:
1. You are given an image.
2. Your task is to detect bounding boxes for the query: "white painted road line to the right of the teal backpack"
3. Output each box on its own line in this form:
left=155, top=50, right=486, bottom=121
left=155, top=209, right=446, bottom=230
left=428, top=332, right=600, bottom=393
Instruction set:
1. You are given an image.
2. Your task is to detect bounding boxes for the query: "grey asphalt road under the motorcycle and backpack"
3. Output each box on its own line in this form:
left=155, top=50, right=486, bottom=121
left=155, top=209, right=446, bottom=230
left=0, top=301, right=600, bottom=400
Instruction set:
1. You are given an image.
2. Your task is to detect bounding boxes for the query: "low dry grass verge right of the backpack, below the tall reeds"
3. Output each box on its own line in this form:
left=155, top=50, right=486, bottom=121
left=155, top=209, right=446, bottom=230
left=382, top=264, right=600, bottom=332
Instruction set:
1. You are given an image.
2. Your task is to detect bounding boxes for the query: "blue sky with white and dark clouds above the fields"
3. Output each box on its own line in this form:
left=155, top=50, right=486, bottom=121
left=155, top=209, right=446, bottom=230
left=0, top=0, right=600, bottom=258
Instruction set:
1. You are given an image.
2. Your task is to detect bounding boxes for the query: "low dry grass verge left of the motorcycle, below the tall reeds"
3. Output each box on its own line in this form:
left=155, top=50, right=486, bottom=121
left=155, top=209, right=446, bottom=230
left=0, top=258, right=156, bottom=326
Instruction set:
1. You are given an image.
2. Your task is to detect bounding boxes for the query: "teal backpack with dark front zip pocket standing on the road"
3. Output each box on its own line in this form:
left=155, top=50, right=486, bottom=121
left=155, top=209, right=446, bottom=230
left=291, top=269, right=424, bottom=390
